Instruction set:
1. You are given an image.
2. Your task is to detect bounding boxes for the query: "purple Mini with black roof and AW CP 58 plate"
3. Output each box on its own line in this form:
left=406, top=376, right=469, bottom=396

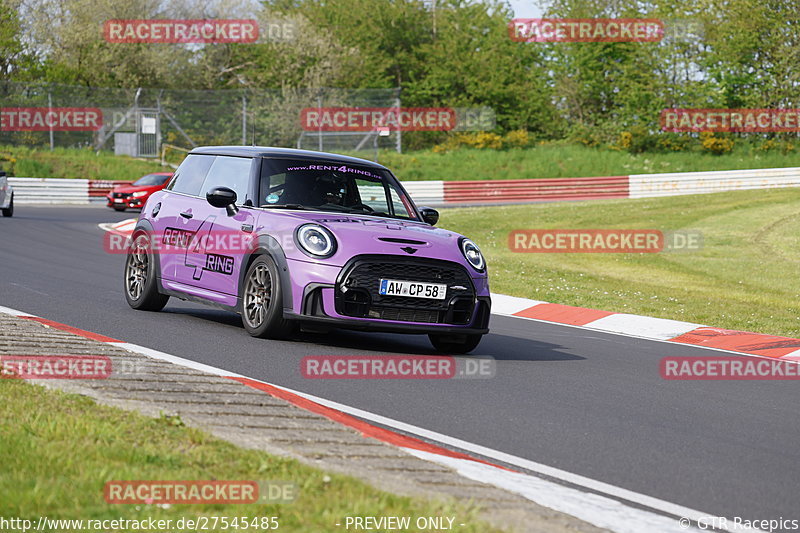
left=125, top=146, right=491, bottom=353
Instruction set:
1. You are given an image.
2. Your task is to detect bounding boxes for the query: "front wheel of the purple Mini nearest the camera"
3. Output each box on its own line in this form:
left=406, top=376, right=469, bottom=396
left=244, top=255, right=295, bottom=339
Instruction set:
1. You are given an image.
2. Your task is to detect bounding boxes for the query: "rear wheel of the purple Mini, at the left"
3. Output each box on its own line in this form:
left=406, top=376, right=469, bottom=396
left=123, top=232, right=169, bottom=311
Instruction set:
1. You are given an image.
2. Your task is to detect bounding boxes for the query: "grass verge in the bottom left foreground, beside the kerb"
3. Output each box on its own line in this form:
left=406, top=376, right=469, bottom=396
left=0, top=379, right=498, bottom=533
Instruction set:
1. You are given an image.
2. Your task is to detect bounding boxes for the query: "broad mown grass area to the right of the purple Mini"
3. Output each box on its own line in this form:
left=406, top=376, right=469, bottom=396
left=440, top=188, right=800, bottom=337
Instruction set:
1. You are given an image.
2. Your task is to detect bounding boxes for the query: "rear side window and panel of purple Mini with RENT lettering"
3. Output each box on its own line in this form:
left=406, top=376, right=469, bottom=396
left=153, top=154, right=216, bottom=280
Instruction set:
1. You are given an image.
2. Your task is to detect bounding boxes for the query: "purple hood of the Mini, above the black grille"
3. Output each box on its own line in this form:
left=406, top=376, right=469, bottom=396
left=256, top=211, right=477, bottom=275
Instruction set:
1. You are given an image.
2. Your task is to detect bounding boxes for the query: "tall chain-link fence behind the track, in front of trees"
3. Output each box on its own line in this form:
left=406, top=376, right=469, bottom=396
left=0, top=82, right=494, bottom=157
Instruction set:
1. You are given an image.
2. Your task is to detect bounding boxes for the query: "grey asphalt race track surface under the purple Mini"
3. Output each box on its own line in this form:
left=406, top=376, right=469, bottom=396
left=0, top=206, right=800, bottom=520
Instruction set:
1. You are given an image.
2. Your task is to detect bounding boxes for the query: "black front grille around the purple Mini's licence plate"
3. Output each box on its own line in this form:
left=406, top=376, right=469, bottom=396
left=336, top=256, right=475, bottom=324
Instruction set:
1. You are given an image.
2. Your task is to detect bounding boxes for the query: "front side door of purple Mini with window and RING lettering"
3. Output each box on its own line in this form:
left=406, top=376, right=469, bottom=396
left=175, top=155, right=257, bottom=296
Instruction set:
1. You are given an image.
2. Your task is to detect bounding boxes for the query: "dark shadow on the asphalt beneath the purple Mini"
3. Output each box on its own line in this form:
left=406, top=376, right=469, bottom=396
left=163, top=307, right=585, bottom=361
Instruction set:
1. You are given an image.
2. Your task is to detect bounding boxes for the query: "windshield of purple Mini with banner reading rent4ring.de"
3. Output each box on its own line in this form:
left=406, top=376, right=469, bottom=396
left=259, top=159, right=417, bottom=220
